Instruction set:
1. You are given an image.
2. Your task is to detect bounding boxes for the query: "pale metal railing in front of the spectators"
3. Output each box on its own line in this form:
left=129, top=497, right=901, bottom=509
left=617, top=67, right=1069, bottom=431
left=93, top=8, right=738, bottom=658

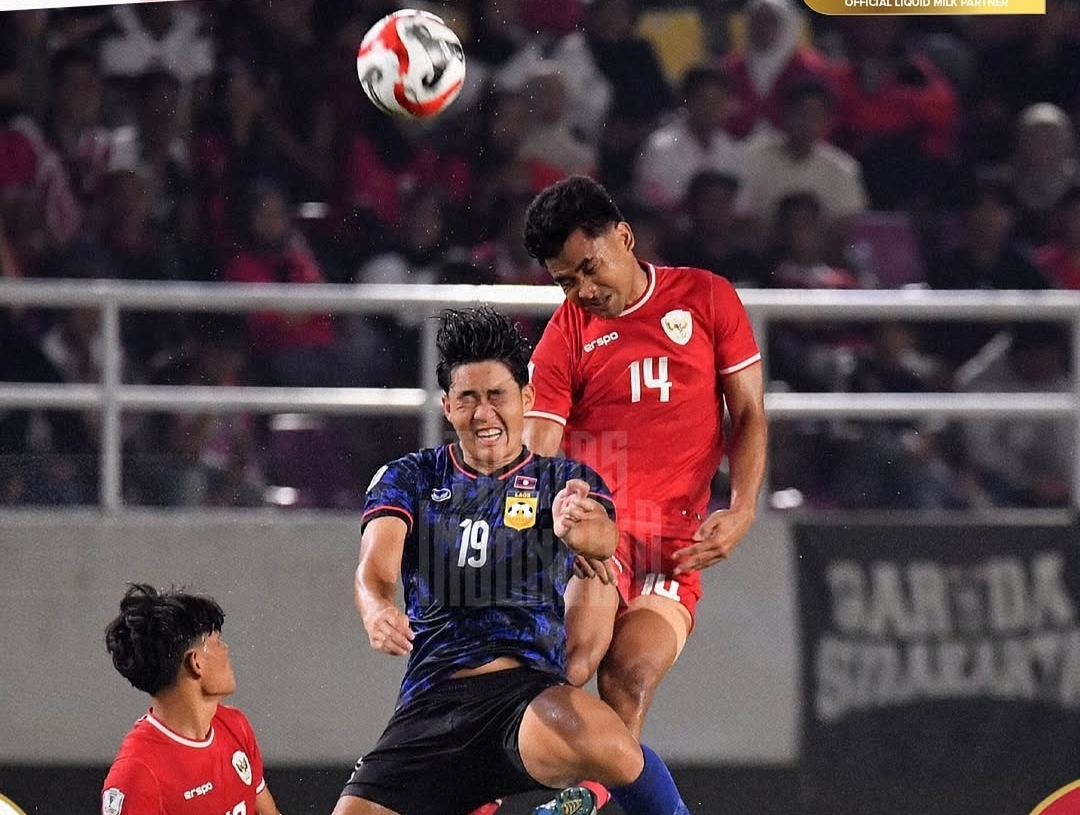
left=0, top=280, right=1080, bottom=513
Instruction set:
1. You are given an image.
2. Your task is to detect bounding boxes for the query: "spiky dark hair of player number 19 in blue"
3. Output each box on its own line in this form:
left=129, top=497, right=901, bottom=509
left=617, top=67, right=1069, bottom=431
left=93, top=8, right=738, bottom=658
left=435, top=305, right=530, bottom=393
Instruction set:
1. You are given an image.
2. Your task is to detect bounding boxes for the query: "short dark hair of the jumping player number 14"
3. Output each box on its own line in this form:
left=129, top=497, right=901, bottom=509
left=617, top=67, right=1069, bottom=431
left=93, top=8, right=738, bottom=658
left=525, top=176, right=625, bottom=263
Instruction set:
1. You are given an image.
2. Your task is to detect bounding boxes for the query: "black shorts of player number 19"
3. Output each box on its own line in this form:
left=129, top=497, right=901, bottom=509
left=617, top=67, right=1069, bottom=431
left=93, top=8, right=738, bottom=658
left=341, top=668, right=566, bottom=815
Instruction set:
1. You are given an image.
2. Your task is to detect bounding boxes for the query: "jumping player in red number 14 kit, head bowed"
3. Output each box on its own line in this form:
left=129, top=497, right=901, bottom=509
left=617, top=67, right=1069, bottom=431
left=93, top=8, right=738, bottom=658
left=525, top=176, right=767, bottom=811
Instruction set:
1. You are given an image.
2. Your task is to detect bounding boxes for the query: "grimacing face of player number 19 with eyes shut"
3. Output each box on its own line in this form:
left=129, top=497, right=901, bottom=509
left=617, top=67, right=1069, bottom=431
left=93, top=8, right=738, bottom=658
left=443, top=362, right=534, bottom=473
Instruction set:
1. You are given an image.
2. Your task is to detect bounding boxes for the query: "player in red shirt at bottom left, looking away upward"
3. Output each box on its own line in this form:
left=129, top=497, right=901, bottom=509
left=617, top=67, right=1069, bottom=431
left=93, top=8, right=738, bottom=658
left=102, top=584, right=280, bottom=815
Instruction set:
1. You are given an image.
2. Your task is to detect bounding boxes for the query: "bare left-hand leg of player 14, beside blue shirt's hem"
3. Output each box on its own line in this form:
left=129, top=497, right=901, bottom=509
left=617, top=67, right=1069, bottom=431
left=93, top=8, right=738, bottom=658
left=563, top=578, right=619, bottom=688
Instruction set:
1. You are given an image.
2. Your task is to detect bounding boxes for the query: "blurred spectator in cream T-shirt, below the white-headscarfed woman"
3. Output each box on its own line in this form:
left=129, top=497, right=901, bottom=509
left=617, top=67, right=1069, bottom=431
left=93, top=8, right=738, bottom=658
left=739, top=79, right=867, bottom=258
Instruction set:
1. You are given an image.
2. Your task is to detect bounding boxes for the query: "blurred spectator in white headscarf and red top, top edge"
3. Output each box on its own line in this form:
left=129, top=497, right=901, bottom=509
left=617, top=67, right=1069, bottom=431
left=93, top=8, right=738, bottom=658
left=721, top=0, right=833, bottom=138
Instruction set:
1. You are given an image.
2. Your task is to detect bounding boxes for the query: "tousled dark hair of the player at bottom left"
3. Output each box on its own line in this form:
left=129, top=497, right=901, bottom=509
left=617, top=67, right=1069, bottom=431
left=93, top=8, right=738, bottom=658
left=105, top=583, right=225, bottom=696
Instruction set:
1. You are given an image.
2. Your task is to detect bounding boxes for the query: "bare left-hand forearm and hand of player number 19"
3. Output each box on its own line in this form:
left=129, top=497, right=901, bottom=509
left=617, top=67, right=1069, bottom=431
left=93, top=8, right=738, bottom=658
left=353, top=515, right=414, bottom=656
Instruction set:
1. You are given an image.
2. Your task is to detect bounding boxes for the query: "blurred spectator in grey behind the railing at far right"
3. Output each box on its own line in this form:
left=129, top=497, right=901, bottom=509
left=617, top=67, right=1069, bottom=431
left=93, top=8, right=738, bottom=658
left=957, top=323, right=1076, bottom=507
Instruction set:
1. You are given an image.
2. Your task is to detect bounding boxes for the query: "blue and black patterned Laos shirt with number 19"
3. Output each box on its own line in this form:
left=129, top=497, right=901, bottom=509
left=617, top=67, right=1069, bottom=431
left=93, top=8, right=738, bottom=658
left=362, top=444, right=615, bottom=706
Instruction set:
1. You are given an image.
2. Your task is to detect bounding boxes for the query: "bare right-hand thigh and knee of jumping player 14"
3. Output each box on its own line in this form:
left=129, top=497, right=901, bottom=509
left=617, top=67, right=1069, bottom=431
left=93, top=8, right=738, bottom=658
left=596, top=594, right=692, bottom=738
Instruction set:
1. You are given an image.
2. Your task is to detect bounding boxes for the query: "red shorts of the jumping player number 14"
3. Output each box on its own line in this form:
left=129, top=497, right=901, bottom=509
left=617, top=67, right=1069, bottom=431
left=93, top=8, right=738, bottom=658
left=612, top=530, right=701, bottom=630
